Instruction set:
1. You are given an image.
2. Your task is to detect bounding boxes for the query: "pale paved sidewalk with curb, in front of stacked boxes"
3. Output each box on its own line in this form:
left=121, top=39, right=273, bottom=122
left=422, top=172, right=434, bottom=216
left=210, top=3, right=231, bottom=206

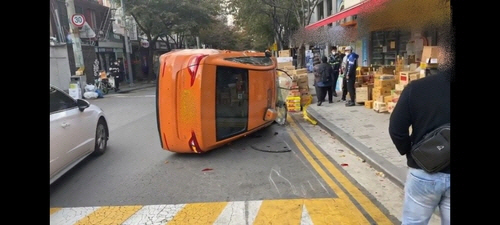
left=307, top=73, right=408, bottom=187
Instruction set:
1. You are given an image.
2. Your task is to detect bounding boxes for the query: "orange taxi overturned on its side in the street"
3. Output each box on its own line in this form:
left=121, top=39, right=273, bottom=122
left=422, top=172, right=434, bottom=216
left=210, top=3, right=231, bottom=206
left=156, top=49, right=277, bottom=153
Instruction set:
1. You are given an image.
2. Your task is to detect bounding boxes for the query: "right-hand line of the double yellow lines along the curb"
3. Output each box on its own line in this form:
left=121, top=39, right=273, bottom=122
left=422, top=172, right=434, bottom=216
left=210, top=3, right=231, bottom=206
left=290, top=118, right=393, bottom=225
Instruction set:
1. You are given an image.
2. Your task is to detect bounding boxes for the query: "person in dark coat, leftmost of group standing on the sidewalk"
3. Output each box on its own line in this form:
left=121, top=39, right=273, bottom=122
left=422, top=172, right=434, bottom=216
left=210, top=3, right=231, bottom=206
left=314, top=56, right=333, bottom=106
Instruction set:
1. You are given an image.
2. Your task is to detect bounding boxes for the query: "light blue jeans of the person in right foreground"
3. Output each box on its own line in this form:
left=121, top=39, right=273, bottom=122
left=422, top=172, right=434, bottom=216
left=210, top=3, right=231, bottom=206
left=402, top=168, right=451, bottom=225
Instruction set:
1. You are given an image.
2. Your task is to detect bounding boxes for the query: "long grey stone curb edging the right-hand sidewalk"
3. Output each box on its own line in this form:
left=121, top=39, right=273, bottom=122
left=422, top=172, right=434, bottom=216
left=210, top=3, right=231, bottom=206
left=306, top=107, right=408, bottom=188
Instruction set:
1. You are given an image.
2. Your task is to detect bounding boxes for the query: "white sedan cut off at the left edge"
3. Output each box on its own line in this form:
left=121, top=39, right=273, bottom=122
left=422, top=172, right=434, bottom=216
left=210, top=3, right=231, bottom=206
left=50, top=85, right=109, bottom=184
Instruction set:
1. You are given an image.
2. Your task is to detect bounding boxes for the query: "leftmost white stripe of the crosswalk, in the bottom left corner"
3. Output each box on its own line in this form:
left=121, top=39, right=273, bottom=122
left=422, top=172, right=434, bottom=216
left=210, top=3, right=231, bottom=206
left=50, top=207, right=99, bottom=225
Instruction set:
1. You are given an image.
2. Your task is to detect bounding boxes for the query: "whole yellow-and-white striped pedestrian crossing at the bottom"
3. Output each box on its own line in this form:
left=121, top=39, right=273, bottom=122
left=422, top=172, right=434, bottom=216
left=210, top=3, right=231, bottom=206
left=50, top=198, right=376, bottom=225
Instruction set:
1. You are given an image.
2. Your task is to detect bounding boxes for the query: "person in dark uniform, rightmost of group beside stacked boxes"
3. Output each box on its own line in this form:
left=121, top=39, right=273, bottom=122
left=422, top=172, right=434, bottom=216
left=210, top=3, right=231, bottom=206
left=342, top=46, right=359, bottom=106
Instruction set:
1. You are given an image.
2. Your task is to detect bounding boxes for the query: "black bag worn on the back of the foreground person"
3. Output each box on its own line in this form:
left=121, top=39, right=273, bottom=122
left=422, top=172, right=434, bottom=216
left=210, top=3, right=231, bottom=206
left=411, top=123, right=450, bottom=173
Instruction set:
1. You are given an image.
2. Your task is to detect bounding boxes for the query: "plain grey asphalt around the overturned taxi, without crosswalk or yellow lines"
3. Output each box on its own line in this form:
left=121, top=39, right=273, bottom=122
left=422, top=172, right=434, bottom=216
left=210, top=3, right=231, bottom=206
left=50, top=88, right=336, bottom=207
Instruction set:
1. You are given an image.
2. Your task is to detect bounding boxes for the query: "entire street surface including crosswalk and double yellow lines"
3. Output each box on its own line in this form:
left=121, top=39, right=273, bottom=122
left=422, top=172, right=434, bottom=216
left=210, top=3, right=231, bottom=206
left=50, top=88, right=414, bottom=224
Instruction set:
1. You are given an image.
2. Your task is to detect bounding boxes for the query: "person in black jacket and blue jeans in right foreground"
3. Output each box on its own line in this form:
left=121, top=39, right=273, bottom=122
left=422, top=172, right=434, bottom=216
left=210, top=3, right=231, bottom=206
left=389, top=66, right=451, bottom=224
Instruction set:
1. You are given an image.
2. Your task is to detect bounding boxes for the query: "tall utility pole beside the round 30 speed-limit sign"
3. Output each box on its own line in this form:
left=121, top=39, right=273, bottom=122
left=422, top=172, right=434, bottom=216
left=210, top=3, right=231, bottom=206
left=66, top=0, right=85, bottom=75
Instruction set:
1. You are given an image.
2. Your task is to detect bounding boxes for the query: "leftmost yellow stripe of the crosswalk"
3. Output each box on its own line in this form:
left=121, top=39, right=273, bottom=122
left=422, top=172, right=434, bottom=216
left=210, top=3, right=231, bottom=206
left=75, top=205, right=142, bottom=225
